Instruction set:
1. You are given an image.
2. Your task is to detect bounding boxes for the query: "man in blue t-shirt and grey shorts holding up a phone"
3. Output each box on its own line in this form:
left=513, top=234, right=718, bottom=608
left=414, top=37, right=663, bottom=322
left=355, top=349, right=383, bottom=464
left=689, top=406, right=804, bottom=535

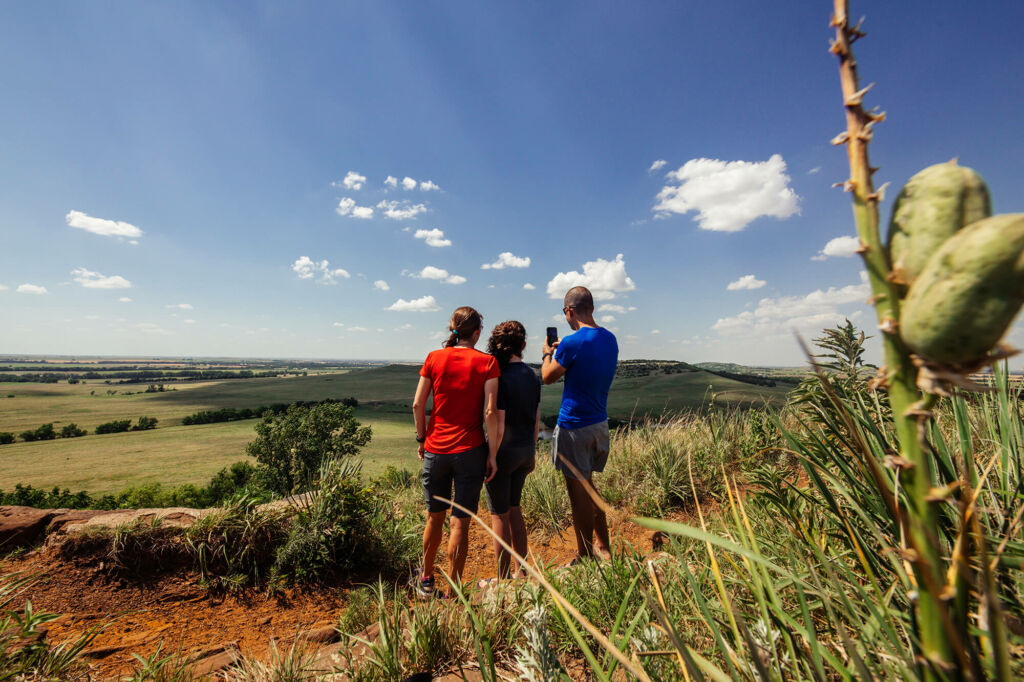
left=541, top=287, right=618, bottom=558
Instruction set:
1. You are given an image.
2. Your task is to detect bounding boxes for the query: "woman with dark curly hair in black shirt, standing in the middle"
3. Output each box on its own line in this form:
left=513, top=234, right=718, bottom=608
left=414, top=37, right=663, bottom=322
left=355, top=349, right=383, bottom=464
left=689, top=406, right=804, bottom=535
left=486, top=321, right=541, bottom=579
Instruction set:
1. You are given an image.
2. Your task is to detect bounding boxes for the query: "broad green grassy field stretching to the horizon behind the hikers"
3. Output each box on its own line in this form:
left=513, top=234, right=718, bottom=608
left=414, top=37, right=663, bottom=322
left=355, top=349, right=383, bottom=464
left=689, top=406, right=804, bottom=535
left=0, top=365, right=788, bottom=494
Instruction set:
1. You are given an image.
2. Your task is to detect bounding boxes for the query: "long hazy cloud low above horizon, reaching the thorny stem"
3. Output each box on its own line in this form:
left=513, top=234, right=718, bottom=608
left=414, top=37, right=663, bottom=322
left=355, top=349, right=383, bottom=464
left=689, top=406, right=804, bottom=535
left=712, top=272, right=870, bottom=338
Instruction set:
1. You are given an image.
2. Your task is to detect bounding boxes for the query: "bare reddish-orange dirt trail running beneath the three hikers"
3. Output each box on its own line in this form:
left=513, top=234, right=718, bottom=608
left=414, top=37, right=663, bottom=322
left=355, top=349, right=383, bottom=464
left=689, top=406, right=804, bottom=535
left=0, top=512, right=651, bottom=680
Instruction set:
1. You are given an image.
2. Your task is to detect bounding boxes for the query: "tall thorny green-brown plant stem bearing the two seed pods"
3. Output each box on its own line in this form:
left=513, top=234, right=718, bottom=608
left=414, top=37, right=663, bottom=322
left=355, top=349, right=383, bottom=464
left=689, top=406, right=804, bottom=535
left=831, top=0, right=966, bottom=680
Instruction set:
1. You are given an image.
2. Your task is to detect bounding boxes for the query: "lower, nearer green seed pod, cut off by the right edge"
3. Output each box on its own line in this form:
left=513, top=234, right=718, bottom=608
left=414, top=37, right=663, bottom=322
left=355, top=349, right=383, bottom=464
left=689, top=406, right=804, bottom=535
left=900, top=213, right=1024, bottom=367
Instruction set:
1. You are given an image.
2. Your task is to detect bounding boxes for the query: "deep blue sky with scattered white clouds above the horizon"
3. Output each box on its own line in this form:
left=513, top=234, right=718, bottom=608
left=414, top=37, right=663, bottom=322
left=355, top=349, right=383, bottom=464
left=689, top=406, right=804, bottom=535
left=0, top=0, right=1024, bottom=365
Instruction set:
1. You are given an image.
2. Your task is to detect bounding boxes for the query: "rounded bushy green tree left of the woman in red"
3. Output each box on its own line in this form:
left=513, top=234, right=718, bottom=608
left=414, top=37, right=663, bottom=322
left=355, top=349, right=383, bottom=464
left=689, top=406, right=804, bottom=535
left=246, top=402, right=372, bottom=495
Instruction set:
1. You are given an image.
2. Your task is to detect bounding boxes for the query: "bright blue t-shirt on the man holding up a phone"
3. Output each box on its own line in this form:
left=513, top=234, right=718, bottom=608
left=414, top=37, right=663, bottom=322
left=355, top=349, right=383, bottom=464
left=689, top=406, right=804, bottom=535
left=555, top=327, right=618, bottom=429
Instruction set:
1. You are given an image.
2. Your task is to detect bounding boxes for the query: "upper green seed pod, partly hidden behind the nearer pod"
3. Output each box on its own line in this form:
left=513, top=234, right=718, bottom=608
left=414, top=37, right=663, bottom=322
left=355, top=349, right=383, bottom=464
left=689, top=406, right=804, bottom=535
left=888, top=161, right=992, bottom=285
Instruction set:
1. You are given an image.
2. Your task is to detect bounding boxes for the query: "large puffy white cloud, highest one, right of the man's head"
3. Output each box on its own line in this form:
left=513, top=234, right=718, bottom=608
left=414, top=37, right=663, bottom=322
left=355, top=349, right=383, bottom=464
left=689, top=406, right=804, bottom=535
left=652, top=154, right=800, bottom=232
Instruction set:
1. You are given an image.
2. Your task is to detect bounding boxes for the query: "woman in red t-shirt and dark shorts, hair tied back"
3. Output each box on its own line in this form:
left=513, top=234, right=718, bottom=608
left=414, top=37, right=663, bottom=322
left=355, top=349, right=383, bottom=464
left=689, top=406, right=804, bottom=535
left=413, top=306, right=502, bottom=598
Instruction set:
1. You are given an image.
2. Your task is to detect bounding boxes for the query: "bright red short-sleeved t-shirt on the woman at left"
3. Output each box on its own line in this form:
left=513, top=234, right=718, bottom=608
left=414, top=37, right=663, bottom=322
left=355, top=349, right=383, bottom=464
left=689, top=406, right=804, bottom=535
left=420, top=346, right=501, bottom=455
